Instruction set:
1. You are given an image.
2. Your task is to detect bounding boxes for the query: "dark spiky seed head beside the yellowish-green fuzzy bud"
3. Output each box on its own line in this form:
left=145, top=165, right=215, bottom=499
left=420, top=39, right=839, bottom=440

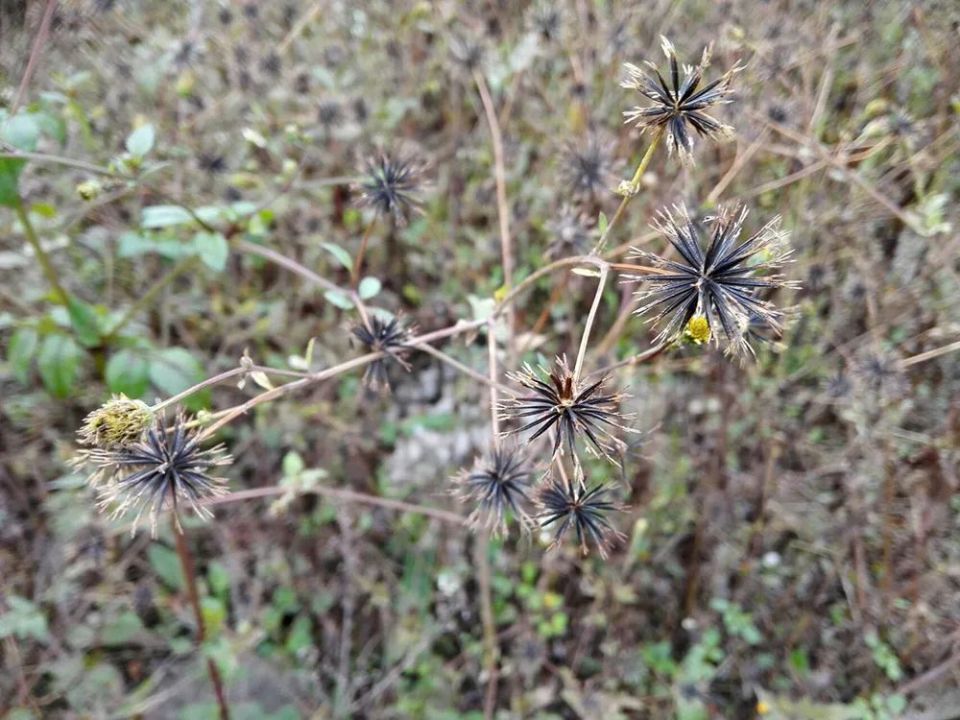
left=74, top=414, right=232, bottom=535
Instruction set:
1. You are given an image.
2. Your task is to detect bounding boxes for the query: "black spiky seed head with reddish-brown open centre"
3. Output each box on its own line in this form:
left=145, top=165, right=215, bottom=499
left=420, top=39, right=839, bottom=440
left=501, top=357, right=630, bottom=460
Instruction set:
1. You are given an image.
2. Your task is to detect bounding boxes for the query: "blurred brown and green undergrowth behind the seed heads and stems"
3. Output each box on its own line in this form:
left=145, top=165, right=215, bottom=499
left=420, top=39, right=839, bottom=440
left=0, top=0, right=960, bottom=720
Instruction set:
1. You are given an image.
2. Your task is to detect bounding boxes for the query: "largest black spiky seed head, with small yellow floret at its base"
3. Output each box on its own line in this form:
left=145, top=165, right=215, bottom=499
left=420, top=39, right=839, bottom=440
left=633, top=205, right=797, bottom=354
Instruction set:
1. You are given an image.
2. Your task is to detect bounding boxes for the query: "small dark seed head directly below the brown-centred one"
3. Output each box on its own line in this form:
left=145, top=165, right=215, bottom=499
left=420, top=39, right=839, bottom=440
left=536, top=464, right=624, bottom=558
